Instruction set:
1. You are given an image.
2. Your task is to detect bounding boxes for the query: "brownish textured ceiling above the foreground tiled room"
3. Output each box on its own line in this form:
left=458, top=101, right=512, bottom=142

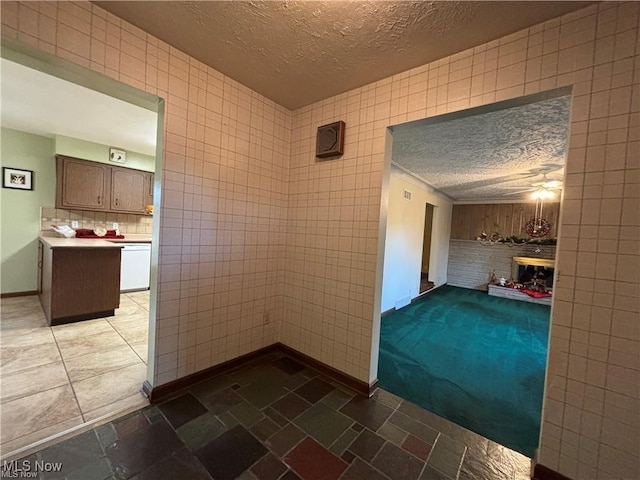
left=93, top=0, right=594, bottom=109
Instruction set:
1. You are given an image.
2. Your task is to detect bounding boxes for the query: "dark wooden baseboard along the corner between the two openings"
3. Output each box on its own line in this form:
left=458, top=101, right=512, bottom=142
left=142, top=343, right=378, bottom=403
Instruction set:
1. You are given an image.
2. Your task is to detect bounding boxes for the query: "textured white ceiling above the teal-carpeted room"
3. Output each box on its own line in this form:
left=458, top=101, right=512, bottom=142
left=392, top=95, right=571, bottom=202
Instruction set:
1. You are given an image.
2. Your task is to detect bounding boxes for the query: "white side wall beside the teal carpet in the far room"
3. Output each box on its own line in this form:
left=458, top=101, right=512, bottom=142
left=381, top=169, right=453, bottom=312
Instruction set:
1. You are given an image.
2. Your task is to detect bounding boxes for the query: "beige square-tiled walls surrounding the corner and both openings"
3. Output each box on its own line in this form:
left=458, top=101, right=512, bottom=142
left=1, top=2, right=640, bottom=479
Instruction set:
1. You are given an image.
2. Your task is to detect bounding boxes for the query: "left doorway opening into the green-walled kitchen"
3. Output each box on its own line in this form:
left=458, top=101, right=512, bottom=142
left=1, top=40, right=164, bottom=456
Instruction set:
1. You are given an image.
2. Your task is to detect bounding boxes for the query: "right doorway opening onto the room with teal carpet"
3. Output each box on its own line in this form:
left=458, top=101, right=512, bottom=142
left=378, top=88, right=571, bottom=457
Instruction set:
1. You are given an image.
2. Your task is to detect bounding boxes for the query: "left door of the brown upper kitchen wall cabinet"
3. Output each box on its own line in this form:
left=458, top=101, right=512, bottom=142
left=56, top=156, right=111, bottom=210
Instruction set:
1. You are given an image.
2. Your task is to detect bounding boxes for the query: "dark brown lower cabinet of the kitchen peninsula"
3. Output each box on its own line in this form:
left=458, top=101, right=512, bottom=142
left=39, top=241, right=121, bottom=325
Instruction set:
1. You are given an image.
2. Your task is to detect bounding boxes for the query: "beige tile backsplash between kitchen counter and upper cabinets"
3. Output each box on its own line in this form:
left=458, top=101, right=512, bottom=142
left=40, top=207, right=153, bottom=234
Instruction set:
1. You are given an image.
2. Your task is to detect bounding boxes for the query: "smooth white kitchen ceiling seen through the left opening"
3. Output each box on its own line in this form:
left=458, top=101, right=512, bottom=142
left=0, top=59, right=157, bottom=155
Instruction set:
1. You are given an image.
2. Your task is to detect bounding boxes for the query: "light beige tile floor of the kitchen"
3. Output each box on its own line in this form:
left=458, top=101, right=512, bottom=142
left=0, top=290, right=149, bottom=455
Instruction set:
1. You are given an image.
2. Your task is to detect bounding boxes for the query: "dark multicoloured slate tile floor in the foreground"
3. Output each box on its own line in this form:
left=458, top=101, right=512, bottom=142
left=2, top=354, right=530, bottom=480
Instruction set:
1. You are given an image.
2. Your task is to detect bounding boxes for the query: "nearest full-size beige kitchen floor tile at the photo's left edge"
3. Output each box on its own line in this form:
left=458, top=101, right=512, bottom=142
left=0, top=385, right=80, bottom=445
